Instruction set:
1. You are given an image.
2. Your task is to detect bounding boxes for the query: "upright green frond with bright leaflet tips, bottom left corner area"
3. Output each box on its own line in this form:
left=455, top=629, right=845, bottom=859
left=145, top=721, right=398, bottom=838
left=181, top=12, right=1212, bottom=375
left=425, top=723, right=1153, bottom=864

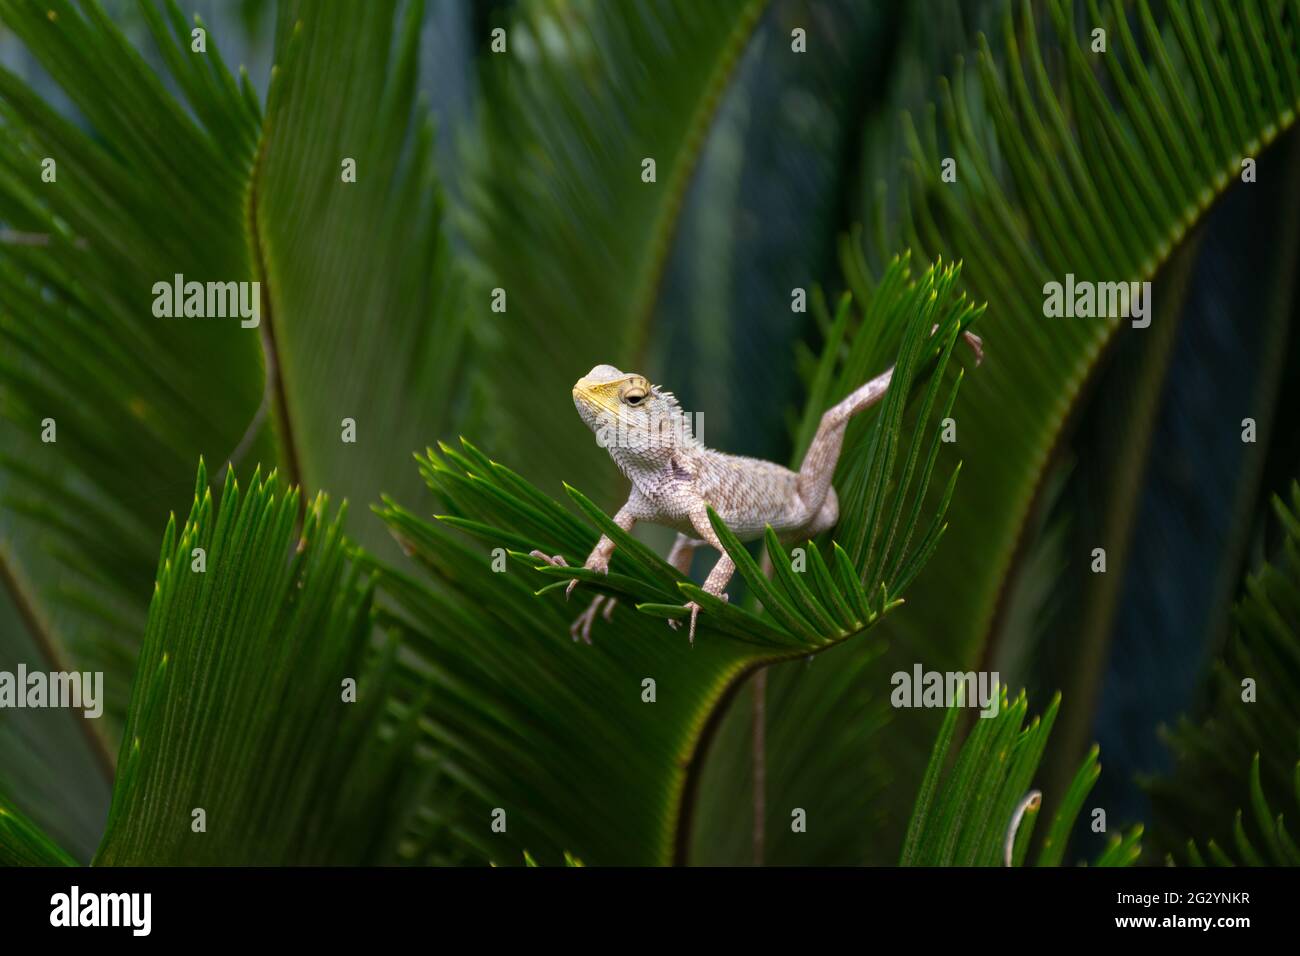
left=95, top=466, right=423, bottom=865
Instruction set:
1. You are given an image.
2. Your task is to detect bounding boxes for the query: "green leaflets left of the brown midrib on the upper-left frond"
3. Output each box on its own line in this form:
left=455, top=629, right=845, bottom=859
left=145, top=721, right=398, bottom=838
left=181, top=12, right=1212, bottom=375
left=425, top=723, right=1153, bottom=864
left=0, top=0, right=260, bottom=686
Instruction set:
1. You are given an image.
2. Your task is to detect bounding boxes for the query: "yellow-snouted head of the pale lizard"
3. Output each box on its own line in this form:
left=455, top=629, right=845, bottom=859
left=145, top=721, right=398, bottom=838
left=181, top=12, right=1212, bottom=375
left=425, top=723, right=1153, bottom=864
left=573, top=365, right=698, bottom=471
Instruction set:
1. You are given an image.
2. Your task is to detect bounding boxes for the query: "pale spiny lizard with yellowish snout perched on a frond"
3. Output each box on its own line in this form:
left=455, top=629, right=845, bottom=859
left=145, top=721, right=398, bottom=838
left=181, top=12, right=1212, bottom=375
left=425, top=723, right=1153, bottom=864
left=533, top=333, right=983, bottom=644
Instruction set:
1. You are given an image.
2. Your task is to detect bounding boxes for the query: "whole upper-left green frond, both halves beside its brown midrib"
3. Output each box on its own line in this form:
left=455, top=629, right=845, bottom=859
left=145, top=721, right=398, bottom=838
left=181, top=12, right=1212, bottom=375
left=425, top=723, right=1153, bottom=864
left=0, top=0, right=464, bottom=829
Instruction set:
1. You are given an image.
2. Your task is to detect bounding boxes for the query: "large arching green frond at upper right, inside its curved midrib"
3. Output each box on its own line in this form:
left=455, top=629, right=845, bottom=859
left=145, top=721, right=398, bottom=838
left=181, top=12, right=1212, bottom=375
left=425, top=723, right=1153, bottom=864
left=859, top=0, right=1300, bottom=681
